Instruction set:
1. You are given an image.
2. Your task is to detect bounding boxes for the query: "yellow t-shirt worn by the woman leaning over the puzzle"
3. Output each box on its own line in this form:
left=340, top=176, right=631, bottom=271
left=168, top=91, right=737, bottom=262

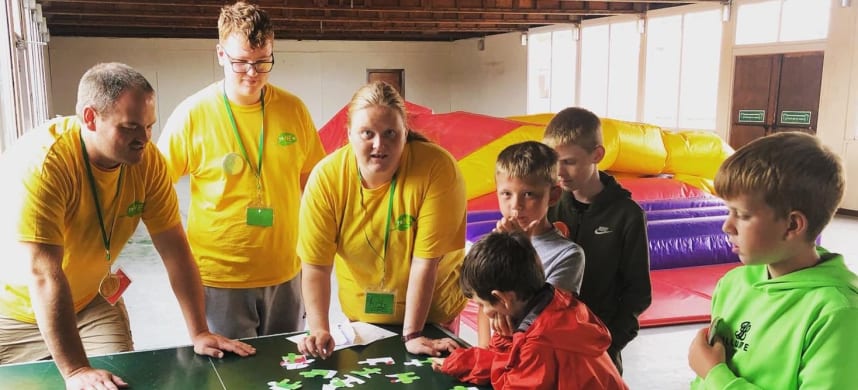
left=298, top=142, right=466, bottom=324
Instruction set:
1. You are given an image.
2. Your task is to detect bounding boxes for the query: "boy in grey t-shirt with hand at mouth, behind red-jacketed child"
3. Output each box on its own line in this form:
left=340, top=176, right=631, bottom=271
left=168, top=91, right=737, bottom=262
left=477, top=141, right=584, bottom=346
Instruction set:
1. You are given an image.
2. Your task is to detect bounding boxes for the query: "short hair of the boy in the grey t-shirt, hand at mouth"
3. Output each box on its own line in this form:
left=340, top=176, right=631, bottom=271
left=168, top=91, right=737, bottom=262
left=495, top=141, right=557, bottom=186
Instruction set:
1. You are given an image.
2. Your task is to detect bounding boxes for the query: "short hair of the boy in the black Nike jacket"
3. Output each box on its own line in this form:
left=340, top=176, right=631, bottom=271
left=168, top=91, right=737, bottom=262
left=542, top=107, right=602, bottom=152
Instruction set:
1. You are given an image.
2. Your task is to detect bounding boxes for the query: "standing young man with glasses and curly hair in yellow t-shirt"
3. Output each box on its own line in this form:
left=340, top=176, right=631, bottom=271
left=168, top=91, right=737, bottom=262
left=158, top=2, right=324, bottom=338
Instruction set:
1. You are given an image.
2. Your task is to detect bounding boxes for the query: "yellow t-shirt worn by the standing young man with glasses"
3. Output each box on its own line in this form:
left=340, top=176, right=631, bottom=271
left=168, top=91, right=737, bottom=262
left=158, top=82, right=325, bottom=288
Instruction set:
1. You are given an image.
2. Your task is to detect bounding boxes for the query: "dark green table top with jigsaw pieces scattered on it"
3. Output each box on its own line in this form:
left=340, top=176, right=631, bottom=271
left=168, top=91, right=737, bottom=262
left=0, top=326, right=488, bottom=390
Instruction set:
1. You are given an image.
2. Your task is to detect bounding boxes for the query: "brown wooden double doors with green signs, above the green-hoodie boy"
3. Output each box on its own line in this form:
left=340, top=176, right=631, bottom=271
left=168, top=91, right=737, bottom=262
left=730, top=52, right=823, bottom=149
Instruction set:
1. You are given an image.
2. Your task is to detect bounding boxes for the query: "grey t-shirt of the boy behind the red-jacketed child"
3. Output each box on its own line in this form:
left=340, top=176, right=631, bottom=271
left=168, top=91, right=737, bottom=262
left=530, top=228, right=584, bottom=294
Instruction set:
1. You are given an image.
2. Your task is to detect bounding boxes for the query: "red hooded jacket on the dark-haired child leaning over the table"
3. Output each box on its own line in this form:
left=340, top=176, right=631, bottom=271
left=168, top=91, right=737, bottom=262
left=441, top=285, right=628, bottom=390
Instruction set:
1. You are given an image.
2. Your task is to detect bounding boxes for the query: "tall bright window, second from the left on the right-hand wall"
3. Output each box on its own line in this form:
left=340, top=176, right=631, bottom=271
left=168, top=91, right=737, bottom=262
left=581, top=20, right=640, bottom=121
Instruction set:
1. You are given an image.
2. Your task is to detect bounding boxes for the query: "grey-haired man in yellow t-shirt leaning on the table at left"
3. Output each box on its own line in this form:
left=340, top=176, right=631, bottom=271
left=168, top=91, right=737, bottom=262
left=0, top=63, right=255, bottom=389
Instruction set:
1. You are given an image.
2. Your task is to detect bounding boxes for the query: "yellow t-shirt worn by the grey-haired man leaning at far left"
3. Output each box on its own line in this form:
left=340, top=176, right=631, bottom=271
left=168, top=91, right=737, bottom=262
left=0, top=116, right=181, bottom=323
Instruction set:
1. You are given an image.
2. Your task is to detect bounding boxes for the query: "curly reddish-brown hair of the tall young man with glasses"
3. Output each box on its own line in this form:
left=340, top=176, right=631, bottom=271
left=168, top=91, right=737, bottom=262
left=217, top=1, right=274, bottom=49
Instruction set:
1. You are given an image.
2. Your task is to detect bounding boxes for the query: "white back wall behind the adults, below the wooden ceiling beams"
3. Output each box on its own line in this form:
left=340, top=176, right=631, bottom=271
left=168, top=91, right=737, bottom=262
left=49, top=34, right=526, bottom=142
